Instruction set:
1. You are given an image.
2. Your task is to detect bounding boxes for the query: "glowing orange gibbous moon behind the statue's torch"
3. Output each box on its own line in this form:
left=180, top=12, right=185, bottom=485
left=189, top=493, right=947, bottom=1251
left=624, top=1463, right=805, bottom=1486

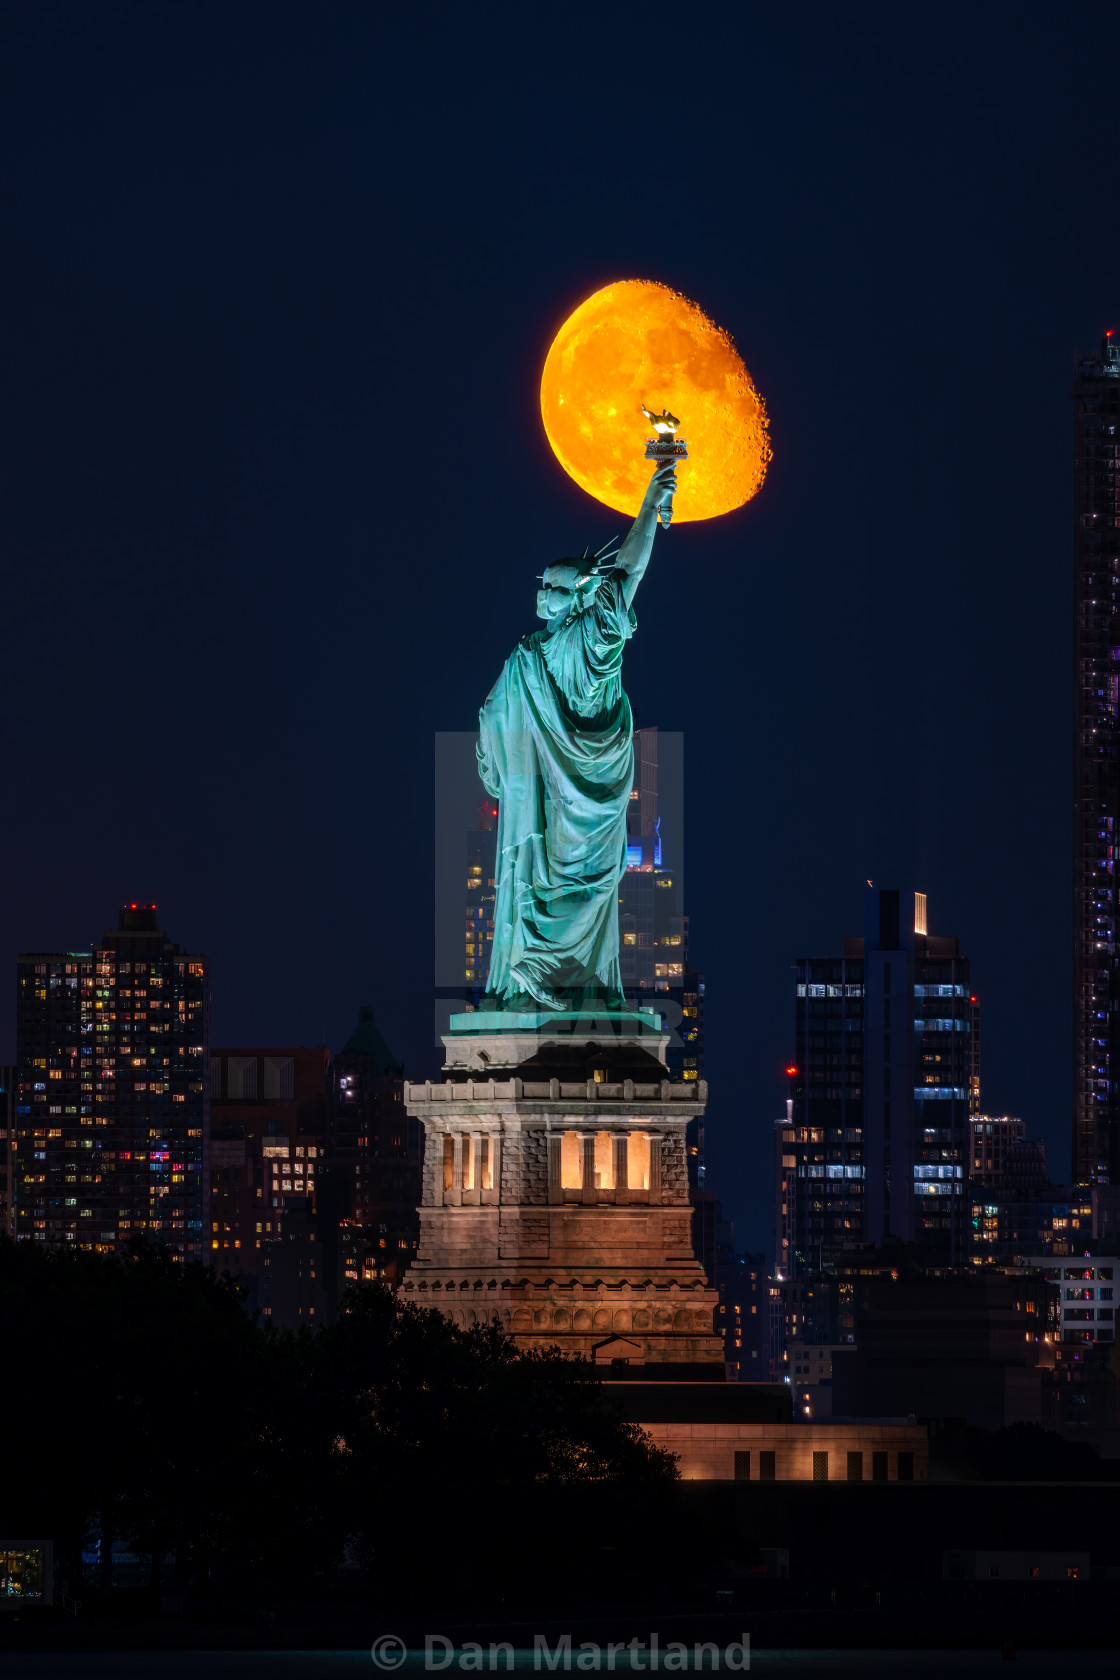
left=541, top=281, right=771, bottom=524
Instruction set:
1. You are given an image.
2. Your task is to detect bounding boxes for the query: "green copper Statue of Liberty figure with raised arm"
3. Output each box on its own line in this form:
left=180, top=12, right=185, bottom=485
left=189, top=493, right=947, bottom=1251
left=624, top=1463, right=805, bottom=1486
left=479, top=462, right=677, bottom=1011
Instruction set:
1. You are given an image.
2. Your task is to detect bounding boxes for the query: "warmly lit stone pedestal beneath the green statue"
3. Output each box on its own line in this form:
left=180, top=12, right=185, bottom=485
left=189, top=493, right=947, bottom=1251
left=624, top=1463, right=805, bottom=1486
left=401, top=1011, right=724, bottom=1366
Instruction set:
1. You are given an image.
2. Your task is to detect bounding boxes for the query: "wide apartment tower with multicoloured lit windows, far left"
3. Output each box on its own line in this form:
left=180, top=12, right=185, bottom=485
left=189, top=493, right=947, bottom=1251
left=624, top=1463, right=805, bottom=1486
left=15, top=904, right=210, bottom=1260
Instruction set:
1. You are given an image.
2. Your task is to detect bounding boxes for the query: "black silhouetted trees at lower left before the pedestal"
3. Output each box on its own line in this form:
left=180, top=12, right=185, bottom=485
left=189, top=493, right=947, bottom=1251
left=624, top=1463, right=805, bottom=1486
left=0, top=1240, right=677, bottom=1584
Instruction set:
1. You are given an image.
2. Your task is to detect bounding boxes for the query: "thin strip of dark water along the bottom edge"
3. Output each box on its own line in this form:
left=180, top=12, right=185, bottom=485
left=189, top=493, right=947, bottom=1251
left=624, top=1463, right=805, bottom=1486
left=0, top=1650, right=1120, bottom=1680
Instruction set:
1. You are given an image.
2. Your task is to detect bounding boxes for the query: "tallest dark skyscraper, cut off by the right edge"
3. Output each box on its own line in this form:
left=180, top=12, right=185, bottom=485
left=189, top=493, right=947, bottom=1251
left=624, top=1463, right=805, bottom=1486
left=1073, top=333, right=1120, bottom=1184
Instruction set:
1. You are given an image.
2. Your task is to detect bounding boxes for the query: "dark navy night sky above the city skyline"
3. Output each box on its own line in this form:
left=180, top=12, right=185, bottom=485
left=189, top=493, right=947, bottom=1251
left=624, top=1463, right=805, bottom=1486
left=0, top=0, right=1120, bottom=1248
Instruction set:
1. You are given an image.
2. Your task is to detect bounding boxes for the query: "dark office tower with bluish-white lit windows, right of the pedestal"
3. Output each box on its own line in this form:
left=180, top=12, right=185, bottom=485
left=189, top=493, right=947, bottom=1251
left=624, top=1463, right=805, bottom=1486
left=785, top=887, right=979, bottom=1278
